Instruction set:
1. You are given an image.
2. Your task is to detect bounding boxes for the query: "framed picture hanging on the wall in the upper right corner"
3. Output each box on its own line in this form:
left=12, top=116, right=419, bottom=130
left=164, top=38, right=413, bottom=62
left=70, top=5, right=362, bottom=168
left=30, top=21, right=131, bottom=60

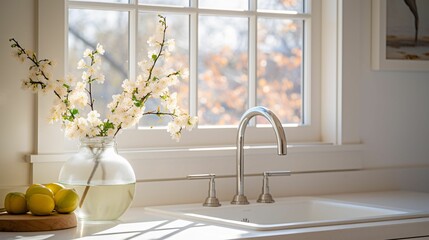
left=371, top=0, right=429, bottom=71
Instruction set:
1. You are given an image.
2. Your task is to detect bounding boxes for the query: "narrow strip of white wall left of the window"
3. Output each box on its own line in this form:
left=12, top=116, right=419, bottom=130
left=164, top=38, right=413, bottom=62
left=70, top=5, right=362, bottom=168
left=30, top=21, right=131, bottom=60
left=0, top=0, right=37, bottom=189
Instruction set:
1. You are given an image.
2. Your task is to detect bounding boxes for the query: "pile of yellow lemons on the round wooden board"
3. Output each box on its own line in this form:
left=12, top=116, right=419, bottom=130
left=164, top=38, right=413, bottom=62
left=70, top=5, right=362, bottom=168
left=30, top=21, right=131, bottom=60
left=4, top=183, right=79, bottom=216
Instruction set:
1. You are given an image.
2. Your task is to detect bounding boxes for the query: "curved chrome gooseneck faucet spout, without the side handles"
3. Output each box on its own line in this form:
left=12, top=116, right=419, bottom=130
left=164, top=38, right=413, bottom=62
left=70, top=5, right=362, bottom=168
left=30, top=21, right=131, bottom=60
left=231, top=106, right=287, bottom=205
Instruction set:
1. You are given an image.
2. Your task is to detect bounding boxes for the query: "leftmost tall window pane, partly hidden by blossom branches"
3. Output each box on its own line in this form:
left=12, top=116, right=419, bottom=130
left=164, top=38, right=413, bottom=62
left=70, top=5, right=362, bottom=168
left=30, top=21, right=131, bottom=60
left=68, top=9, right=128, bottom=117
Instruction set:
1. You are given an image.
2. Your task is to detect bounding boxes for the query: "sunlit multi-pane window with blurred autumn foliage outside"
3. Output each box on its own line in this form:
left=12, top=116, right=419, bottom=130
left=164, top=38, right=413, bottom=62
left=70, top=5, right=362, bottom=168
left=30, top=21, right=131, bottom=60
left=37, top=0, right=320, bottom=152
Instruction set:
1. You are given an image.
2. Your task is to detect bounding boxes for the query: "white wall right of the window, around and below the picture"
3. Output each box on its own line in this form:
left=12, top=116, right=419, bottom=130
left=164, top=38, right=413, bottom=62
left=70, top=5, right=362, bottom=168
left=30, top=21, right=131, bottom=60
left=343, top=0, right=429, bottom=167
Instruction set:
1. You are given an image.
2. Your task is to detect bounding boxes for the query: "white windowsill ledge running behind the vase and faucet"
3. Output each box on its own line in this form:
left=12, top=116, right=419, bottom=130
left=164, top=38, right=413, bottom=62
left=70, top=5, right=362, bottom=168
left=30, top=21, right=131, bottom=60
left=29, top=143, right=363, bottom=182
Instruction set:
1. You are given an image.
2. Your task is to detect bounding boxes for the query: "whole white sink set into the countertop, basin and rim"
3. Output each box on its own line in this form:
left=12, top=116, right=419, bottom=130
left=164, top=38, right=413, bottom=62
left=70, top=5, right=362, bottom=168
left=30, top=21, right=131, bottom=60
left=146, top=197, right=428, bottom=231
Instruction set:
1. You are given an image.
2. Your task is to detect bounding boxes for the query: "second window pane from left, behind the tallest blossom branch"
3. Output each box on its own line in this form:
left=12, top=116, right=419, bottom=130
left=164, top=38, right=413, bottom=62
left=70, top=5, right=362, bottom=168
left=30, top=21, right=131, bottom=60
left=137, top=13, right=189, bottom=127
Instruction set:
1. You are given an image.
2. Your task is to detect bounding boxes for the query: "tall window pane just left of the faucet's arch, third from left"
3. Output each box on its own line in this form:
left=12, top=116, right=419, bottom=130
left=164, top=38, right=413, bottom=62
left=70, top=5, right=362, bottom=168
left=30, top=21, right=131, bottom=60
left=198, top=16, right=248, bottom=125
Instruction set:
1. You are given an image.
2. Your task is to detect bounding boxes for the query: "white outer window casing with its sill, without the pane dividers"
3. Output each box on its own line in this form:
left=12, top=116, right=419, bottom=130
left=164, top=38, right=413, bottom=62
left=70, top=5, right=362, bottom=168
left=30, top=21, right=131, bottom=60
left=28, top=0, right=364, bottom=186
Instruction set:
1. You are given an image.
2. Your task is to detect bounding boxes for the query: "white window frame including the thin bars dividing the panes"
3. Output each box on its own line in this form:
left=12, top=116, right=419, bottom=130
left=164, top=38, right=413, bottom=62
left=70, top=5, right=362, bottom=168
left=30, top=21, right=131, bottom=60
left=37, top=0, right=320, bottom=153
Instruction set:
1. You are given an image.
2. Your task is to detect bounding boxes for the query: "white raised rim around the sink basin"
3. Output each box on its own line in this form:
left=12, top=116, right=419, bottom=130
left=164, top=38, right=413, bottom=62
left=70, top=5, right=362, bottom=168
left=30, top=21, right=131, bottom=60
left=145, top=196, right=429, bottom=231
